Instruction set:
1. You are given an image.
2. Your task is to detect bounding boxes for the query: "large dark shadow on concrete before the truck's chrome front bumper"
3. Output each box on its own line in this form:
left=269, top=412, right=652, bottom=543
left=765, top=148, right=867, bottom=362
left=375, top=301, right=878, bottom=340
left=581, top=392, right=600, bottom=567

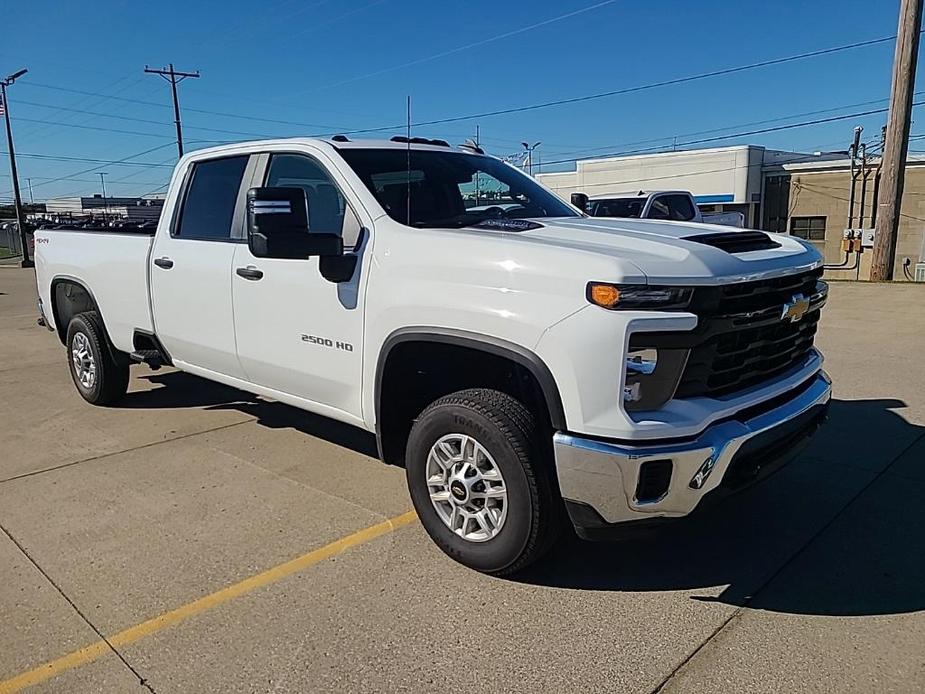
left=515, top=400, right=925, bottom=616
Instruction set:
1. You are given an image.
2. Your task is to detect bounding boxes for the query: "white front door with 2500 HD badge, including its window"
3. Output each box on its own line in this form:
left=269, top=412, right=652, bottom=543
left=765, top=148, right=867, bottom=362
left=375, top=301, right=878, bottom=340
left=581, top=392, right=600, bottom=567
left=232, top=152, right=371, bottom=417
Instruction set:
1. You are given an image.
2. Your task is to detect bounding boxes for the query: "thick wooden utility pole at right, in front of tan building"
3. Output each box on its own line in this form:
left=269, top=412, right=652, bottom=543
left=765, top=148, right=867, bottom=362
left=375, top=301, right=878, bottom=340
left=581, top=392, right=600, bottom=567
left=870, top=0, right=923, bottom=282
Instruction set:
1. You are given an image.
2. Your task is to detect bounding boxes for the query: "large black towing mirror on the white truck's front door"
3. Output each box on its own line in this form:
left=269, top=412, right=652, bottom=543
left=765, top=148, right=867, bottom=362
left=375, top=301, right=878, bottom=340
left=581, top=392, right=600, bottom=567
left=247, top=188, right=344, bottom=260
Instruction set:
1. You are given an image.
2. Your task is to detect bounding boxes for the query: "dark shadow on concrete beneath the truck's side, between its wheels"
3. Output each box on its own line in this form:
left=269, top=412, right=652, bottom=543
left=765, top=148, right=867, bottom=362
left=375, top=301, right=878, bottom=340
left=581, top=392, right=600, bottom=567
left=126, top=371, right=379, bottom=458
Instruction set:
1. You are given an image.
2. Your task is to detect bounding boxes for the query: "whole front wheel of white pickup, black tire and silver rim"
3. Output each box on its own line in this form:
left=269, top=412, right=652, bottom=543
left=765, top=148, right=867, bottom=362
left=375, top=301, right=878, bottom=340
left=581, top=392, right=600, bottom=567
left=405, top=388, right=560, bottom=575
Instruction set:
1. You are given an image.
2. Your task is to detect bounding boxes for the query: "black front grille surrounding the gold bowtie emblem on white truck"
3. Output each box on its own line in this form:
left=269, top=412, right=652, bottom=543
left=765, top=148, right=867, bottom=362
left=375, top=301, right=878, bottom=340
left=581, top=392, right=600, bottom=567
left=675, top=269, right=827, bottom=398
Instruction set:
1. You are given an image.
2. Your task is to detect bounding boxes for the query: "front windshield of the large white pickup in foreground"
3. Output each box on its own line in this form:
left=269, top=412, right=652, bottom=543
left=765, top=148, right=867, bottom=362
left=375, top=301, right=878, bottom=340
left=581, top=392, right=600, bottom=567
left=332, top=149, right=580, bottom=228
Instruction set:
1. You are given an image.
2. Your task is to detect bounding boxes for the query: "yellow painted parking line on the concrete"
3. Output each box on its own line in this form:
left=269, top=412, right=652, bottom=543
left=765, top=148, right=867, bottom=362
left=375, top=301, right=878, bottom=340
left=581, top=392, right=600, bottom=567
left=0, top=511, right=417, bottom=694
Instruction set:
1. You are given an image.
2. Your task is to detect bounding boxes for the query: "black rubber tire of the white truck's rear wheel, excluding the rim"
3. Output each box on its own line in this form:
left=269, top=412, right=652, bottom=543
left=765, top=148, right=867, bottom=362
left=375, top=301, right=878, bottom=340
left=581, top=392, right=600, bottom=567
left=67, top=311, right=129, bottom=405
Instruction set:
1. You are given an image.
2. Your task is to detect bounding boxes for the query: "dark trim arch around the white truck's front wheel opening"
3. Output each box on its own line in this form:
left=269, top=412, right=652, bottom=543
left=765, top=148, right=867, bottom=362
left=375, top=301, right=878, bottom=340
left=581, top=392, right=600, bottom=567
left=374, top=326, right=567, bottom=430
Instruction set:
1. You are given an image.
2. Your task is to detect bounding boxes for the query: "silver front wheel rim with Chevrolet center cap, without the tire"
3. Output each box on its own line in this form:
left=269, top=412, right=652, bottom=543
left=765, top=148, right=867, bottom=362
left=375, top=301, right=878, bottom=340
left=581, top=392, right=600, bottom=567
left=425, top=434, right=507, bottom=542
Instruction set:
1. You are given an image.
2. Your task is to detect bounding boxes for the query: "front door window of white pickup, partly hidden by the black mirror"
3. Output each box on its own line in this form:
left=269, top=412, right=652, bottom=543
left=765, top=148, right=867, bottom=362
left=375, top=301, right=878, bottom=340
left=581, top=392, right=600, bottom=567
left=265, top=154, right=360, bottom=248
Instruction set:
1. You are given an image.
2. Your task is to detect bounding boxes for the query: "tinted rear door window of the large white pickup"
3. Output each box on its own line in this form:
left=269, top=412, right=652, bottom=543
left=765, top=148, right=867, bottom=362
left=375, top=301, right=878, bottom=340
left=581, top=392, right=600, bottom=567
left=174, top=155, right=248, bottom=241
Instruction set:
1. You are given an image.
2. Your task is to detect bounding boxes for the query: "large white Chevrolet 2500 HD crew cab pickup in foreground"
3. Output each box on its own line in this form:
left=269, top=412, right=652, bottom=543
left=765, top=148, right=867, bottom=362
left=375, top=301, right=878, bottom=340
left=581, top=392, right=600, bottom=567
left=35, top=136, right=830, bottom=574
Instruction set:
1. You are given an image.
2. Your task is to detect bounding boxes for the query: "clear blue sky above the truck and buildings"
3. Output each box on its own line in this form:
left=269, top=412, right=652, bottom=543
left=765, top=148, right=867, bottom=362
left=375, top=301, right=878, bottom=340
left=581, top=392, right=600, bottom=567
left=0, top=0, right=925, bottom=200
